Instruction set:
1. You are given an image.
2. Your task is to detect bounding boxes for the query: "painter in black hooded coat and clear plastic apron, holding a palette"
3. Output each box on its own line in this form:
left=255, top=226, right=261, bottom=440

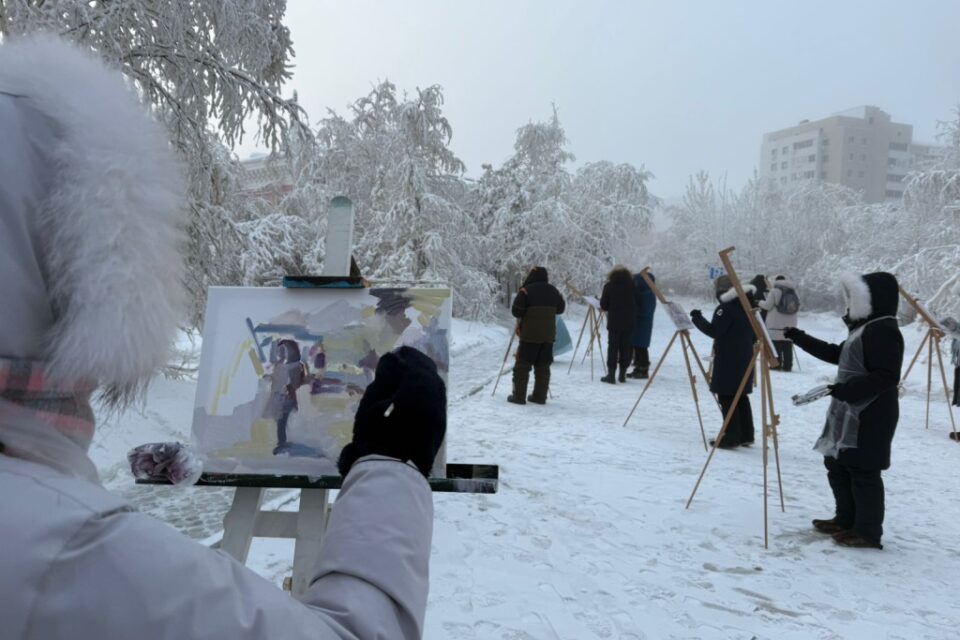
left=785, top=272, right=903, bottom=549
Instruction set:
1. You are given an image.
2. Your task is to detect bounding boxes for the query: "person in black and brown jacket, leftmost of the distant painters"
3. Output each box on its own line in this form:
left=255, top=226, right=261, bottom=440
left=507, top=267, right=566, bottom=404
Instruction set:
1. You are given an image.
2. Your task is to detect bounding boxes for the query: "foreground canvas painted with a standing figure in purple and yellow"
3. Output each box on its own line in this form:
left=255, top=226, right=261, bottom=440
left=193, top=287, right=451, bottom=475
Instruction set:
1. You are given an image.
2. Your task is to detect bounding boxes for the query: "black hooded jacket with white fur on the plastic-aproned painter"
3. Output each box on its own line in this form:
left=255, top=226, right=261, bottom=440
left=790, top=272, right=903, bottom=470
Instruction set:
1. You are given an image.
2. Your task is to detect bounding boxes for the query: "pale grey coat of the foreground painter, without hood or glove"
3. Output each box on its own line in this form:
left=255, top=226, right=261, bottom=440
left=0, top=403, right=433, bottom=640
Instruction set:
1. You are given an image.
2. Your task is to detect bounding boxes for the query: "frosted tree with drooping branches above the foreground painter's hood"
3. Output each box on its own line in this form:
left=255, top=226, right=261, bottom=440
left=0, top=0, right=309, bottom=322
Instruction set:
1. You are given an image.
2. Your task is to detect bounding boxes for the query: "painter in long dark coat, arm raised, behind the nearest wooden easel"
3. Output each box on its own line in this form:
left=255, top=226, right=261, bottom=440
left=690, top=275, right=756, bottom=449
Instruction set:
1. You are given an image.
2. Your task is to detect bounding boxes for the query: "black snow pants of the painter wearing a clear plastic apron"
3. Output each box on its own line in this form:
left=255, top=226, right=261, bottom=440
left=823, top=458, right=884, bottom=542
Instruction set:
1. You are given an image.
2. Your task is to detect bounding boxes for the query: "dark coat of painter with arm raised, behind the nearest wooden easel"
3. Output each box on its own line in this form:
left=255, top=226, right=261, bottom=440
left=690, top=285, right=756, bottom=396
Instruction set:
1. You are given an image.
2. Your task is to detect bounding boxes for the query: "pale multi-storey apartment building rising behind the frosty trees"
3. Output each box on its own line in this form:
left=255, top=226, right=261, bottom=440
left=760, top=106, right=938, bottom=202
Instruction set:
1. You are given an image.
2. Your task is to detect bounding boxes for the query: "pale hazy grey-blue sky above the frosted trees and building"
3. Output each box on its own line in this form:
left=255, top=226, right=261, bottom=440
left=239, top=0, right=960, bottom=198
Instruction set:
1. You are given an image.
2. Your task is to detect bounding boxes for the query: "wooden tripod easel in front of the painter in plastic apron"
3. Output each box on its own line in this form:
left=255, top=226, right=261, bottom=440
left=686, top=247, right=786, bottom=549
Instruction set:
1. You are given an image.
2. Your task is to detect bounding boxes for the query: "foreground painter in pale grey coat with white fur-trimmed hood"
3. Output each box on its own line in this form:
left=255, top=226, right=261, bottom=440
left=0, top=36, right=446, bottom=640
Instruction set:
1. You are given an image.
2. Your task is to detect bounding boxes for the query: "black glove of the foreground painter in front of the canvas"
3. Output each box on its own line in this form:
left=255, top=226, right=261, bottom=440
left=337, top=347, right=447, bottom=477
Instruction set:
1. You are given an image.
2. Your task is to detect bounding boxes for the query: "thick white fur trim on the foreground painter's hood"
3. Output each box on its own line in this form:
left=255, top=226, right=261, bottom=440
left=0, top=35, right=185, bottom=405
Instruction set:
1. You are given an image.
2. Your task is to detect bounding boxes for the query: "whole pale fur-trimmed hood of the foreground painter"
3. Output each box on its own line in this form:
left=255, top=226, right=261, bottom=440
left=0, top=36, right=185, bottom=405
